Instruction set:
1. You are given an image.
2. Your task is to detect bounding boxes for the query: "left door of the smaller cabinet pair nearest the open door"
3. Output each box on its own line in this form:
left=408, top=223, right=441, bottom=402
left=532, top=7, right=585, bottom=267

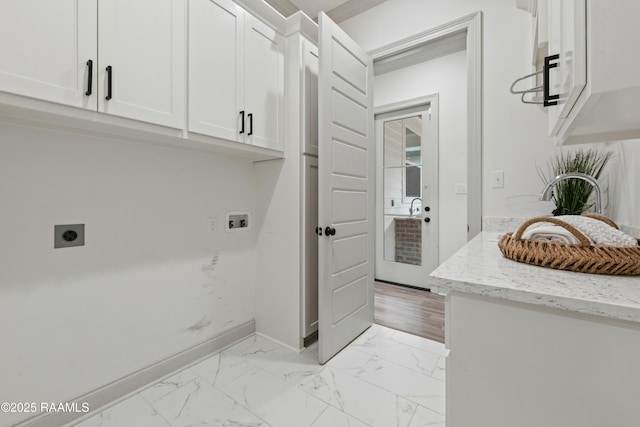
left=189, top=0, right=245, bottom=141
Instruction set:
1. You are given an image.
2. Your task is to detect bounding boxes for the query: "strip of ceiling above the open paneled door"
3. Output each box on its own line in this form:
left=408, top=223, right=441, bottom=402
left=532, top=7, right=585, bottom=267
left=265, top=0, right=385, bottom=22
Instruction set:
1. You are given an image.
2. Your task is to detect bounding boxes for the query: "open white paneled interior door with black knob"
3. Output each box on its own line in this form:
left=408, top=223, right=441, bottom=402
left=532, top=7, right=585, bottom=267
left=318, top=13, right=375, bottom=363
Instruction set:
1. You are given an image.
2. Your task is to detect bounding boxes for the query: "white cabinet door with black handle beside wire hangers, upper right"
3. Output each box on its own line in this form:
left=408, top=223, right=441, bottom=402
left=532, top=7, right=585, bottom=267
left=548, top=0, right=587, bottom=136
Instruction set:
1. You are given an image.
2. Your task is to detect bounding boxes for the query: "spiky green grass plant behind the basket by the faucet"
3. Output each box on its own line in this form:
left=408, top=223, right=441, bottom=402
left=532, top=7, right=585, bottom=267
left=536, top=149, right=611, bottom=215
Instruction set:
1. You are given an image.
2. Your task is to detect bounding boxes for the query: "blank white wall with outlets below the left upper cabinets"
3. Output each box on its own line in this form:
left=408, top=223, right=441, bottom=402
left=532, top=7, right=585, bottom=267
left=0, top=124, right=255, bottom=426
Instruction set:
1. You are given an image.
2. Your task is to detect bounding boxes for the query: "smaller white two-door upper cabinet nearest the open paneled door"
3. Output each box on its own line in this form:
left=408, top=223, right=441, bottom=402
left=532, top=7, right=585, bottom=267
left=189, top=0, right=284, bottom=151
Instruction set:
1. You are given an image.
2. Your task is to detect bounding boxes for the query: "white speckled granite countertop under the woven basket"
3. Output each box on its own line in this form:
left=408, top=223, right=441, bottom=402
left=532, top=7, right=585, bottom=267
left=427, top=231, right=640, bottom=323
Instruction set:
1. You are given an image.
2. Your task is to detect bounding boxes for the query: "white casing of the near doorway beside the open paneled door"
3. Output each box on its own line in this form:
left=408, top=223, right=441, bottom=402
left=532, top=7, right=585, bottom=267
left=368, top=11, right=482, bottom=241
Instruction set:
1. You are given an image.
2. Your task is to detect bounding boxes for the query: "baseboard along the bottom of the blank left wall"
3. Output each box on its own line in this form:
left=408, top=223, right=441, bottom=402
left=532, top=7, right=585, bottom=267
left=12, top=320, right=256, bottom=427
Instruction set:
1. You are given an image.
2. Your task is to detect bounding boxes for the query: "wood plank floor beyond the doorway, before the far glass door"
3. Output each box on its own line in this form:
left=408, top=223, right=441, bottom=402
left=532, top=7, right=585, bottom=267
left=374, top=282, right=444, bottom=343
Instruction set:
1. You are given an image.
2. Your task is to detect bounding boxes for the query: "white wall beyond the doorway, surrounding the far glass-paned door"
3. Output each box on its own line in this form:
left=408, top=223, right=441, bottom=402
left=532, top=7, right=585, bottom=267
left=374, top=51, right=467, bottom=261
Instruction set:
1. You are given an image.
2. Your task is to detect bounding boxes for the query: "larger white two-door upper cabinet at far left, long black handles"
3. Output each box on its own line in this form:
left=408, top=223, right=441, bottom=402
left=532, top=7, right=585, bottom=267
left=0, top=0, right=185, bottom=128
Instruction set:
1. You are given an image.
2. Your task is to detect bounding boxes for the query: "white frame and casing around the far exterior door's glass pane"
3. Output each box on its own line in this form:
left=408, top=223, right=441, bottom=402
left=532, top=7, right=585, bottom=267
left=374, top=94, right=440, bottom=288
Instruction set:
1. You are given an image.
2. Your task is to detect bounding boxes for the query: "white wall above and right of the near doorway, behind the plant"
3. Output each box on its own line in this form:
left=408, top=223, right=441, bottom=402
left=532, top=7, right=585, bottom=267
left=341, top=0, right=555, bottom=224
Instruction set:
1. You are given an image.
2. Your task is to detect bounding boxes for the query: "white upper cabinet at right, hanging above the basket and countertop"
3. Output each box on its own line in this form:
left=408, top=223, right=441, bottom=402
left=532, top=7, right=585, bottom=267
left=538, top=0, right=640, bottom=144
